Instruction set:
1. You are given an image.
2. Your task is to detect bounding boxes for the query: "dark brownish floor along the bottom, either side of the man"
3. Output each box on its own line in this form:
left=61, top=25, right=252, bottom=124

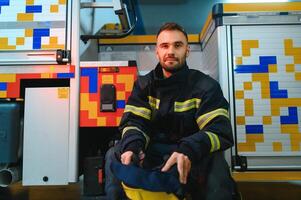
left=0, top=181, right=301, bottom=200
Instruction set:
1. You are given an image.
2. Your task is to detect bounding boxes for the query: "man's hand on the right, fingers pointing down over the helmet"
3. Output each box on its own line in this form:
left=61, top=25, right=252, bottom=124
left=161, top=152, right=191, bottom=184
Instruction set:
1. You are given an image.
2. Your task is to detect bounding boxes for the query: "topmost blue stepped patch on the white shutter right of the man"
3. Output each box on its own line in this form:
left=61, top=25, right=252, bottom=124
left=234, top=56, right=277, bottom=73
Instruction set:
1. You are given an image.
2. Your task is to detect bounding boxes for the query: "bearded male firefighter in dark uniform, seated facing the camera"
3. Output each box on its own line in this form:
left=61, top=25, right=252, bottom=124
left=106, top=23, right=234, bottom=200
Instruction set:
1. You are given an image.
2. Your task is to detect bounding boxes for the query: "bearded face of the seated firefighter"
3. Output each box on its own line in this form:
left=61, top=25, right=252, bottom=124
left=156, top=30, right=190, bottom=76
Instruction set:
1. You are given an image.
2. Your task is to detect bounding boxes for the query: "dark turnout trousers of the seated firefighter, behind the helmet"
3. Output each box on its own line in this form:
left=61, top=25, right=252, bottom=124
left=105, top=143, right=237, bottom=200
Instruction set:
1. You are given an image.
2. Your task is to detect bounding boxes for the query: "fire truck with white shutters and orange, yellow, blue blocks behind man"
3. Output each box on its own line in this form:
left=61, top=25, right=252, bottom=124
left=0, top=0, right=301, bottom=198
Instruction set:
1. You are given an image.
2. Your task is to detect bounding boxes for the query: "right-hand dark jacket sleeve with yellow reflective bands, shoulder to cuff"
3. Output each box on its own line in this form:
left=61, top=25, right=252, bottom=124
left=178, top=81, right=233, bottom=162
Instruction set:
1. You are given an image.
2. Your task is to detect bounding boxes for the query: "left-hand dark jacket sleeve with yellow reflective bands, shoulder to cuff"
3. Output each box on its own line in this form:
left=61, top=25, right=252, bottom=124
left=119, top=77, right=152, bottom=153
